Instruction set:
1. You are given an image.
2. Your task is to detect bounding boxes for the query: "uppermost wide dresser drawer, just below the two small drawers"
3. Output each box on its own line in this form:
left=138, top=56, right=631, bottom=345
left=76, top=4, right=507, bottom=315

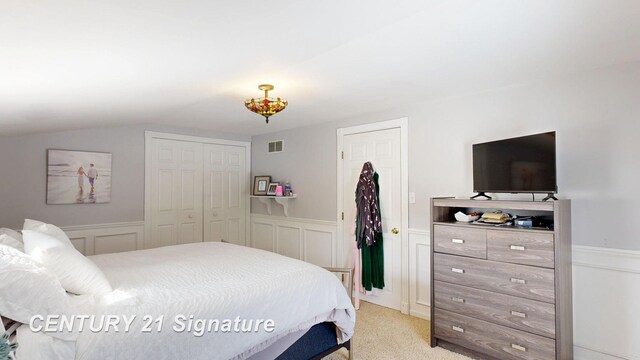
left=433, top=254, right=555, bottom=303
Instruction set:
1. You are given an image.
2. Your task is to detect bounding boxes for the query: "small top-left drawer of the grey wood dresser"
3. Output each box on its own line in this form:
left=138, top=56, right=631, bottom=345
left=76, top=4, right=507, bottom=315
left=433, top=225, right=487, bottom=259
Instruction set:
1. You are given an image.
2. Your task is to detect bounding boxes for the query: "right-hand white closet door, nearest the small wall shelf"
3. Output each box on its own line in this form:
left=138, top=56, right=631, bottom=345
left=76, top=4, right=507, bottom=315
left=204, top=144, right=249, bottom=245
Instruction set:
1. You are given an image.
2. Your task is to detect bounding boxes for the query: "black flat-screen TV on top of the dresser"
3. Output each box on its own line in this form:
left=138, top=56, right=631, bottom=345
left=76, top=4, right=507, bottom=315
left=473, top=131, right=558, bottom=193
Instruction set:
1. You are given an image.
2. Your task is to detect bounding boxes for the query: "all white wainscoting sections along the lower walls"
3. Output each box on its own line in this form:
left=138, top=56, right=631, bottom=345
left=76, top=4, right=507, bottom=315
left=63, top=218, right=640, bottom=360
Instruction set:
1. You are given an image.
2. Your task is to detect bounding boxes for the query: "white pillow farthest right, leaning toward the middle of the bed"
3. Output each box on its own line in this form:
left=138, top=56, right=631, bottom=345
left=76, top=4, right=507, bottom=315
left=22, top=230, right=113, bottom=295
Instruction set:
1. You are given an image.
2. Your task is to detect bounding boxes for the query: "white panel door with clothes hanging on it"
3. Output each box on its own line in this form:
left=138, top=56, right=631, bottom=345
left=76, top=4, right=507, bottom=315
left=342, top=128, right=403, bottom=310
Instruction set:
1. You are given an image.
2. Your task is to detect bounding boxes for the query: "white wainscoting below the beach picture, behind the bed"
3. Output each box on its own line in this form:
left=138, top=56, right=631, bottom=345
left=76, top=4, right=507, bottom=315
left=62, top=221, right=144, bottom=256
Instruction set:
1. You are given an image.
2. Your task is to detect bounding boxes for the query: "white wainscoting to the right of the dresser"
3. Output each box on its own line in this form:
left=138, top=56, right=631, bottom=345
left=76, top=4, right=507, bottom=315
left=572, top=245, right=640, bottom=360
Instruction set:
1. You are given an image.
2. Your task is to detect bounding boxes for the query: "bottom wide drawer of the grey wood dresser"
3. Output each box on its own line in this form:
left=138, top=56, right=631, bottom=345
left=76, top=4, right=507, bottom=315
left=434, top=309, right=555, bottom=360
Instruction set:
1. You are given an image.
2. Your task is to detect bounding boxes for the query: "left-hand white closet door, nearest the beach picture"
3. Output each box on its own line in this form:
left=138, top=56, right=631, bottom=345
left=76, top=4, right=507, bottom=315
left=147, top=138, right=202, bottom=247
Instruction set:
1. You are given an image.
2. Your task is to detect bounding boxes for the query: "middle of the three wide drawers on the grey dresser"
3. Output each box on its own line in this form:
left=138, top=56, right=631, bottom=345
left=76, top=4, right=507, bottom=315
left=433, top=281, right=556, bottom=338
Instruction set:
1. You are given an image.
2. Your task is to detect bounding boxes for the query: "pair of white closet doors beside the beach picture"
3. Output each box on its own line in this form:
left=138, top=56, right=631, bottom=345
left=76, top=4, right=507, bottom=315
left=146, top=138, right=248, bottom=247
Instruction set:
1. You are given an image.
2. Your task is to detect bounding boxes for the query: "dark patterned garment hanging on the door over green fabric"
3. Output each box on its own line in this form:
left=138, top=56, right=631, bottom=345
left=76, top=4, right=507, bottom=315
left=356, top=162, right=382, bottom=249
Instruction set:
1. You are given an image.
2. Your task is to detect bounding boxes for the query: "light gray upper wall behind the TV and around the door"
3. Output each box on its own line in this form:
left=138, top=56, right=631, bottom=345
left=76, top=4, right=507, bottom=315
left=252, top=64, right=640, bottom=250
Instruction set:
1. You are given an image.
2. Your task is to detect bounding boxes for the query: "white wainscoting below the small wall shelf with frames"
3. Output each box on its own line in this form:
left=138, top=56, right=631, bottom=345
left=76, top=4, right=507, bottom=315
left=250, top=214, right=337, bottom=267
